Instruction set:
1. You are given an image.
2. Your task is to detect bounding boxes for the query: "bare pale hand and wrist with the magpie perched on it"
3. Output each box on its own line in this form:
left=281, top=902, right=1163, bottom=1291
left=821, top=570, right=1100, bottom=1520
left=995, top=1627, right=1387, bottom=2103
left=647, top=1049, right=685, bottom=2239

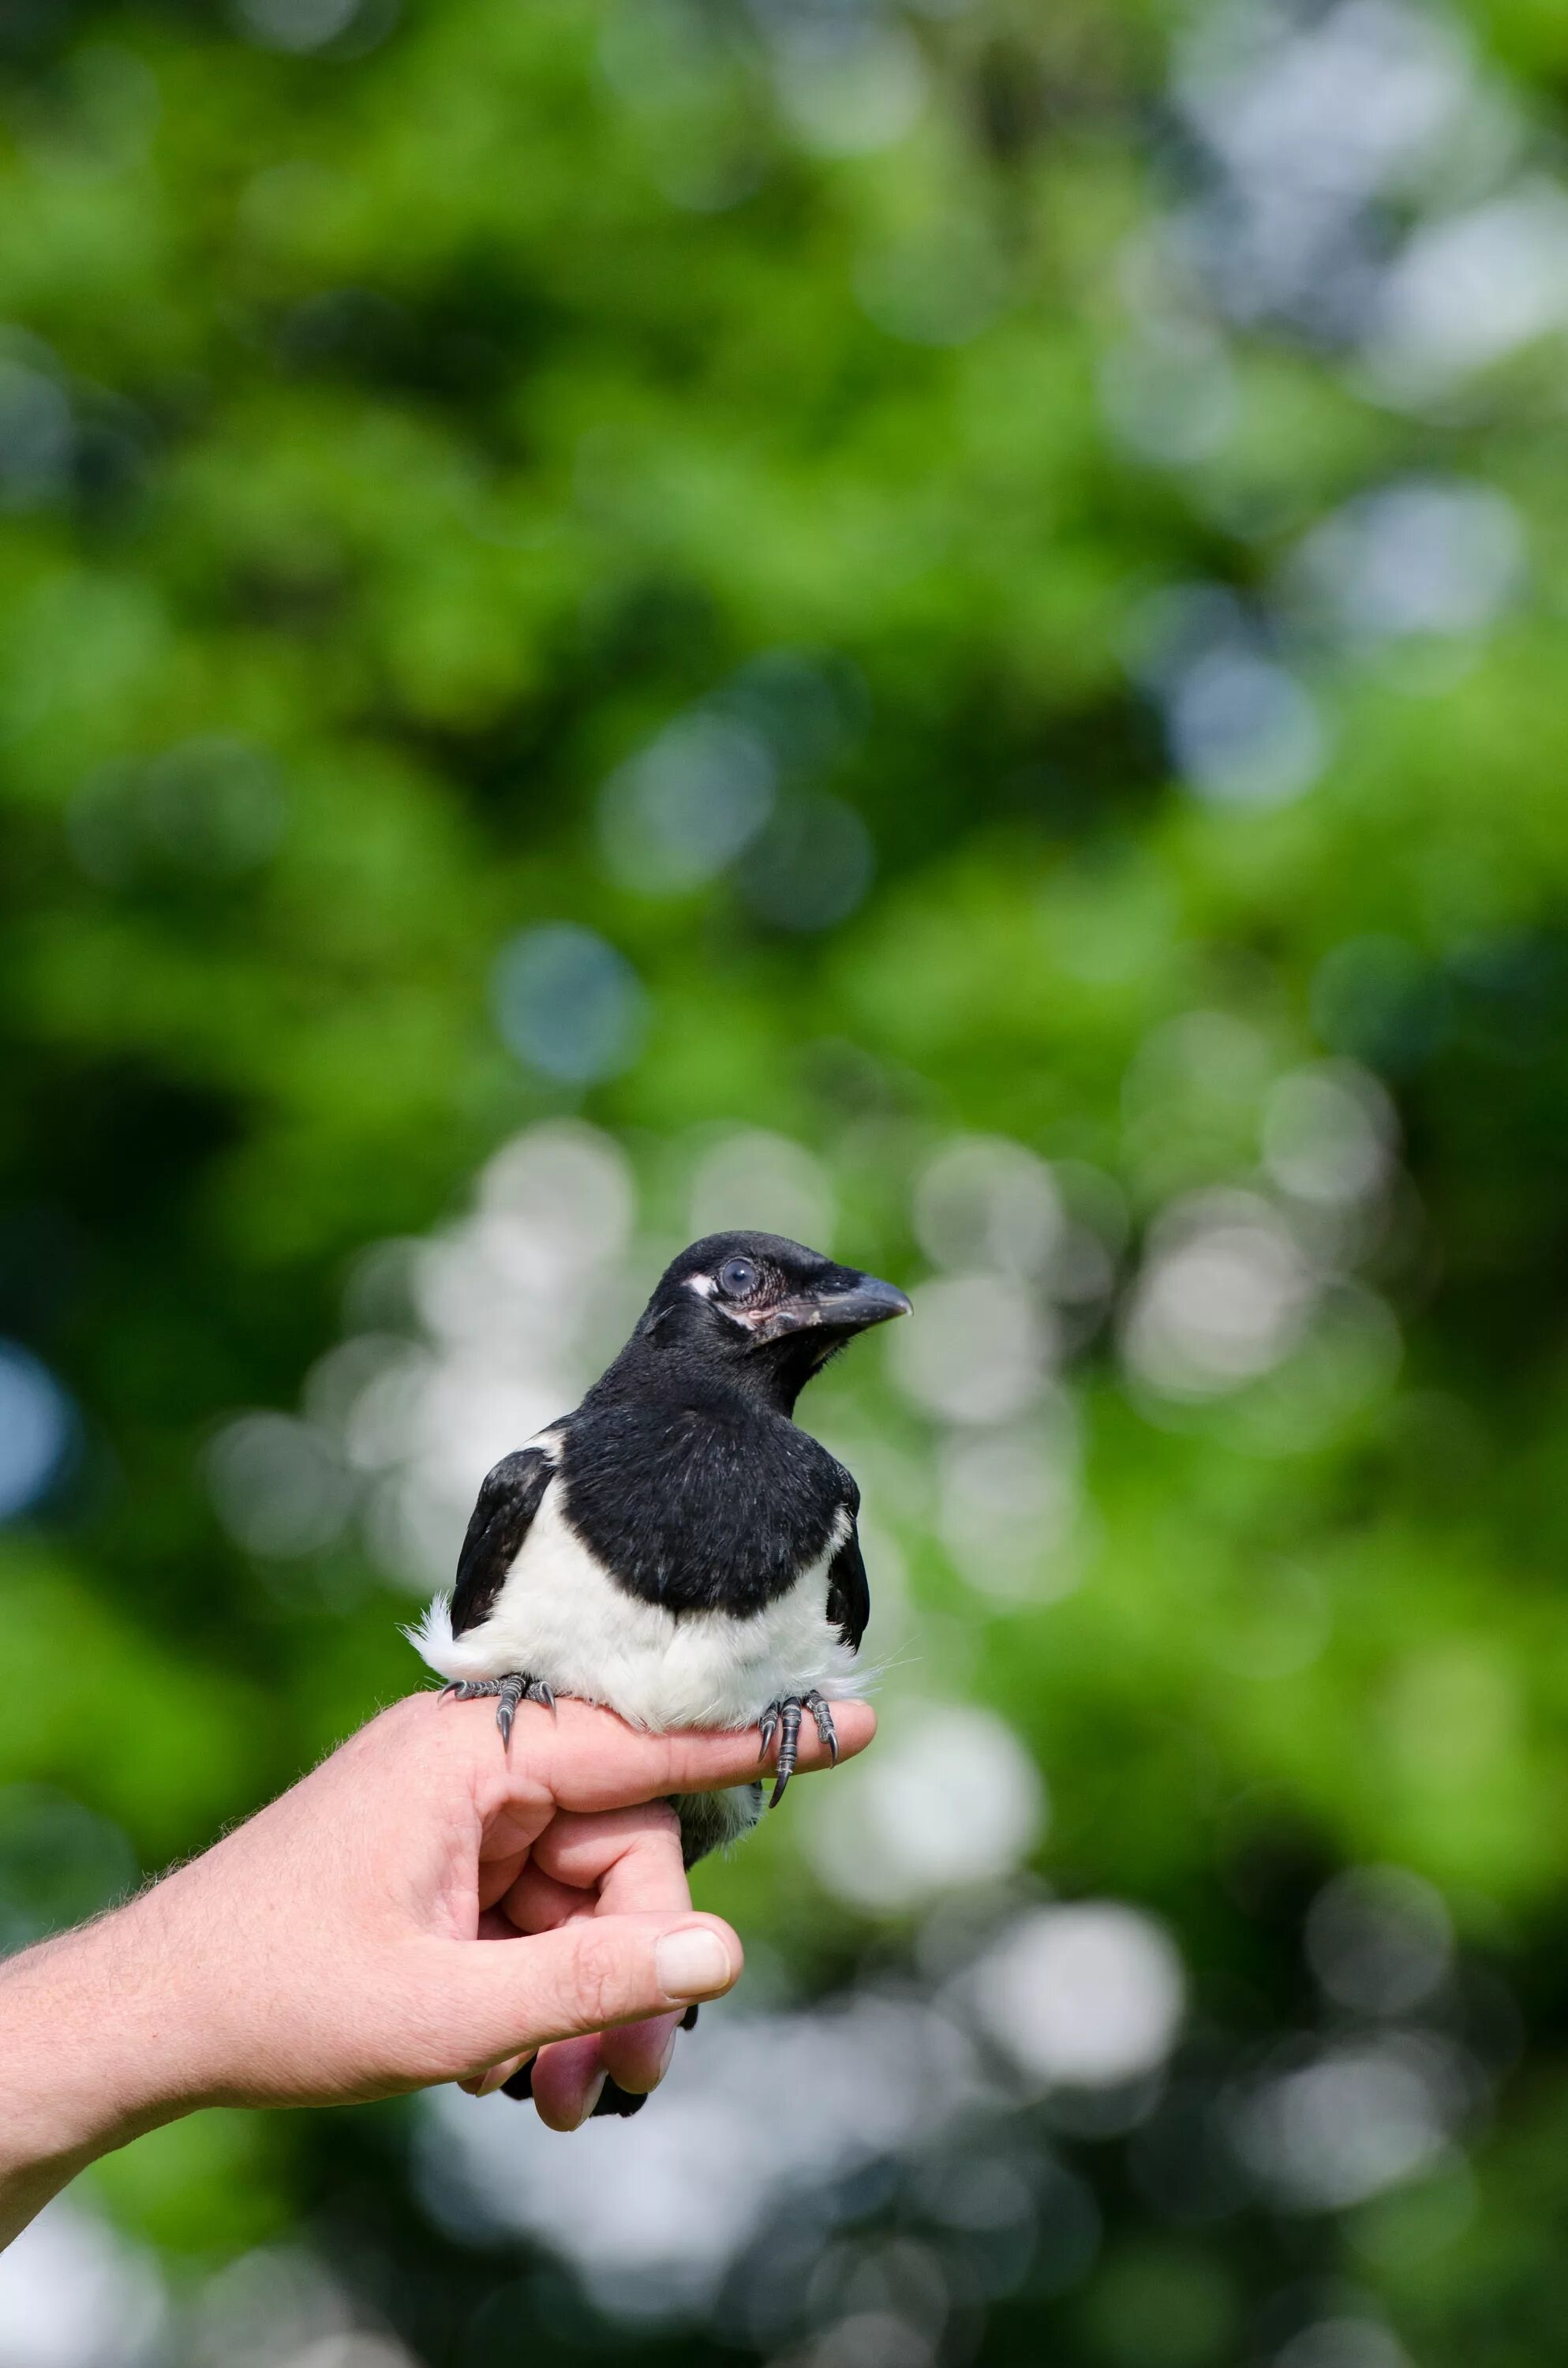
left=0, top=1693, right=877, bottom=2245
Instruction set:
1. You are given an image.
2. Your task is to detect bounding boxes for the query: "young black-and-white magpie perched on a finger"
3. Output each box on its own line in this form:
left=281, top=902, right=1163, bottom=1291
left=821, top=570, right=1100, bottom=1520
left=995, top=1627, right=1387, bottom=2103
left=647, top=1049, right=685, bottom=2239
left=410, top=1234, right=910, bottom=2112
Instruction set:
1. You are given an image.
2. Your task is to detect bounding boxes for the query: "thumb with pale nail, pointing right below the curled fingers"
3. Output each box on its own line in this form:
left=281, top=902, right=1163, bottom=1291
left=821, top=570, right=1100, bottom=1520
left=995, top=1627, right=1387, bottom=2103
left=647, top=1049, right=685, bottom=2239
left=436, top=1909, right=743, bottom=2063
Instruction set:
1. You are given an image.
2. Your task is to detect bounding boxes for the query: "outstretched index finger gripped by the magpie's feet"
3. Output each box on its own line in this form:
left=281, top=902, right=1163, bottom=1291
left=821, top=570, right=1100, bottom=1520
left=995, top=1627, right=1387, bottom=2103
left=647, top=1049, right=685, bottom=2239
left=492, top=1700, right=877, bottom=1814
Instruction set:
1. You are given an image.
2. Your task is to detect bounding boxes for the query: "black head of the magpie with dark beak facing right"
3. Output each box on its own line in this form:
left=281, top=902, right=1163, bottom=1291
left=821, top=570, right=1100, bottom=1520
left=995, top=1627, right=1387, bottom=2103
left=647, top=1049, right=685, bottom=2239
left=634, top=1234, right=910, bottom=1409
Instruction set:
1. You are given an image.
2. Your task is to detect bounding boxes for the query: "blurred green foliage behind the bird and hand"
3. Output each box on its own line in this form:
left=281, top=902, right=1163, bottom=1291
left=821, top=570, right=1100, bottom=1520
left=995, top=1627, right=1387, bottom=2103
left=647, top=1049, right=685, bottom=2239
left=0, top=0, right=1568, bottom=2368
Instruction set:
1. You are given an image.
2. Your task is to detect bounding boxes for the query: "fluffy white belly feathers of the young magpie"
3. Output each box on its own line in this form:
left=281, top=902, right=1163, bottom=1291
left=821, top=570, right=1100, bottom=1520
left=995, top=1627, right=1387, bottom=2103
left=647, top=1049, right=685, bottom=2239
left=410, top=1478, right=855, bottom=1731
